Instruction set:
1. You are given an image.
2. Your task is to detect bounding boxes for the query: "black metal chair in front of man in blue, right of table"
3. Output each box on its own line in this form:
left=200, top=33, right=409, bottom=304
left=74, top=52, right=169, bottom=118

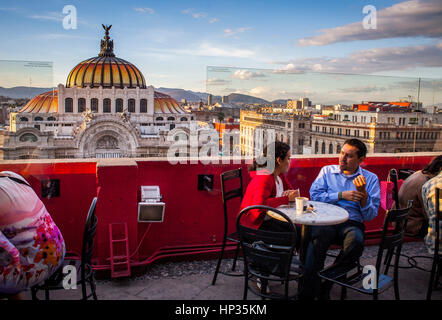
left=319, top=201, right=411, bottom=300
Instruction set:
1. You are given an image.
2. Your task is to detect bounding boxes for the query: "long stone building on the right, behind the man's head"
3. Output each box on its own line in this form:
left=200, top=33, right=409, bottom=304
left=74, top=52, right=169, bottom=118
left=311, top=108, right=442, bottom=154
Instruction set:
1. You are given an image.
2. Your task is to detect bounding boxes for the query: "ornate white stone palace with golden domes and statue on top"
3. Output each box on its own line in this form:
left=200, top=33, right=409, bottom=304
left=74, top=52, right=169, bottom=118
left=0, top=26, right=197, bottom=159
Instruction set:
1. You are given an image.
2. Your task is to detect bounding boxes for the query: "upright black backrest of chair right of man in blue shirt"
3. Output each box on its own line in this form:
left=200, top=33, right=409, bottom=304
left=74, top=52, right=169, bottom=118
left=376, top=200, right=412, bottom=274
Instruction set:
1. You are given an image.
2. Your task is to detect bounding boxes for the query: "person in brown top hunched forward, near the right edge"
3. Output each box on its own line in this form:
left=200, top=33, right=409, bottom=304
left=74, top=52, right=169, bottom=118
left=399, top=156, right=442, bottom=238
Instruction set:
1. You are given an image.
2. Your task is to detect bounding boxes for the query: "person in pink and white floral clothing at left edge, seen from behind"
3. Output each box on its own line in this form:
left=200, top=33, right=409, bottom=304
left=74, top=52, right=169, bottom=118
left=0, top=171, right=65, bottom=299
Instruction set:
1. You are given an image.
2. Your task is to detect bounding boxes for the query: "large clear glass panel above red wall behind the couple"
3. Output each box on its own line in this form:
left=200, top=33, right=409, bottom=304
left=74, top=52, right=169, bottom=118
left=205, top=66, right=442, bottom=155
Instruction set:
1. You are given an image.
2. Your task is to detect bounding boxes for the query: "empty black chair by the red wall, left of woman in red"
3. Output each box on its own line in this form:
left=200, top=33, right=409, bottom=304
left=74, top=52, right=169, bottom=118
left=212, top=168, right=243, bottom=285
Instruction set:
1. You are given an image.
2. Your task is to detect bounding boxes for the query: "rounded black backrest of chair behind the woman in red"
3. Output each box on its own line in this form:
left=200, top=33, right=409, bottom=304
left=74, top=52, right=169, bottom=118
left=236, top=205, right=296, bottom=279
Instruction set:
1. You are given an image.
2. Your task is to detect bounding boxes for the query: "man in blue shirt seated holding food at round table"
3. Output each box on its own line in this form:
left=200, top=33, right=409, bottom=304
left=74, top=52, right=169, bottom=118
left=300, top=139, right=381, bottom=298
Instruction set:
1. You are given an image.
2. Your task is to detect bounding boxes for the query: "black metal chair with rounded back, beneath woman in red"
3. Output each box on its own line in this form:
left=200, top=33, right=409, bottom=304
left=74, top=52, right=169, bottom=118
left=236, top=205, right=304, bottom=300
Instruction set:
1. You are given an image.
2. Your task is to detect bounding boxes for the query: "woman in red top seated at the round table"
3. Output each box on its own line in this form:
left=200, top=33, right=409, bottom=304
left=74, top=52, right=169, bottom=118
left=240, top=141, right=299, bottom=231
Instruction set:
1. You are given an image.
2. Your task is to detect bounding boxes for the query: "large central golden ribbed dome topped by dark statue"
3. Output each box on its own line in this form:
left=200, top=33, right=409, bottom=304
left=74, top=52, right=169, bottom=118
left=66, top=25, right=146, bottom=89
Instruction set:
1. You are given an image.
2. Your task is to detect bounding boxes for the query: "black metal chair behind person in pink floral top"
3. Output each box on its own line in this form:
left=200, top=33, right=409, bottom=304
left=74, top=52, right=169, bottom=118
left=31, top=197, right=98, bottom=300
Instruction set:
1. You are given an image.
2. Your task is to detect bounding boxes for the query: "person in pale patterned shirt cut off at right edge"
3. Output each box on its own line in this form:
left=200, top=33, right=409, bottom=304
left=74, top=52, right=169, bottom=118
left=422, top=172, right=442, bottom=254
